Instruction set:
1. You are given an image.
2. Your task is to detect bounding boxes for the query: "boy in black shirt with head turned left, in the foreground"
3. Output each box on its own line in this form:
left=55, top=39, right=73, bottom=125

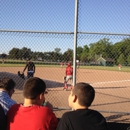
left=57, top=83, right=107, bottom=130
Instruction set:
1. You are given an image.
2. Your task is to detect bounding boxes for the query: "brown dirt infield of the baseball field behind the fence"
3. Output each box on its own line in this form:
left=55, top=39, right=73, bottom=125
left=0, top=67, right=130, bottom=123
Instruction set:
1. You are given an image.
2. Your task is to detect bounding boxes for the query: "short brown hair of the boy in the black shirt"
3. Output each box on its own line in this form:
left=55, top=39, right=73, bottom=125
left=72, top=82, right=95, bottom=107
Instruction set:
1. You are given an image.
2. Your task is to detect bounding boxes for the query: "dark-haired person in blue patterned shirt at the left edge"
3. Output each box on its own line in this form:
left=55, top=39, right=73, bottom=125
left=0, top=77, right=16, bottom=114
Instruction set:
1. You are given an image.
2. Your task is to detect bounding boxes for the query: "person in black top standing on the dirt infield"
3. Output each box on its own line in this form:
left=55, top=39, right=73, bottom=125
left=23, top=59, right=35, bottom=78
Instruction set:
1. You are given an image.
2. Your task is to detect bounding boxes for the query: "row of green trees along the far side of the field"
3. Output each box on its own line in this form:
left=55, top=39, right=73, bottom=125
left=3, top=38, right=130, bottom=65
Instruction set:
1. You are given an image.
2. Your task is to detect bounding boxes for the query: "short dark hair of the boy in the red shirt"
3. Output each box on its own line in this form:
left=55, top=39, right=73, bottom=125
left=23, top=77, right=46, bottom=99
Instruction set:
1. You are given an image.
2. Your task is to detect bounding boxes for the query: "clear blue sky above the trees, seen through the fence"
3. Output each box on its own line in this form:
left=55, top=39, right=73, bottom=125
left=0, top=0, right=130, bottom=54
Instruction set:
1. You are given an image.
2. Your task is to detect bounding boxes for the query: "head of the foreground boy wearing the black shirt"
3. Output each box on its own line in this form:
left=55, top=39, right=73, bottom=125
left=68, top=82, right=95, bottom=108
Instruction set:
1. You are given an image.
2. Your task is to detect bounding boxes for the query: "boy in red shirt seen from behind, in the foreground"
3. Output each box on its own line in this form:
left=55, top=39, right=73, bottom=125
left=7, top=77, right=58, bottom=130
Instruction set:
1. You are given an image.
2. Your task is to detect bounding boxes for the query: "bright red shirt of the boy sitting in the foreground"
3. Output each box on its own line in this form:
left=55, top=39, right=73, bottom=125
left=7, top=104, right=58, bottom=130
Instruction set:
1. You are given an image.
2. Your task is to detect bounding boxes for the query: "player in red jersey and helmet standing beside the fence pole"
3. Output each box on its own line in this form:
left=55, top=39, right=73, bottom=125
left=63, top=63, right=73, bottom=90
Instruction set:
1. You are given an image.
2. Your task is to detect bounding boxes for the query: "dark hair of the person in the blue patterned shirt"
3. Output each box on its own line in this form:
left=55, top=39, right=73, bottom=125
left=0, top=77, right=16, bottom=91
